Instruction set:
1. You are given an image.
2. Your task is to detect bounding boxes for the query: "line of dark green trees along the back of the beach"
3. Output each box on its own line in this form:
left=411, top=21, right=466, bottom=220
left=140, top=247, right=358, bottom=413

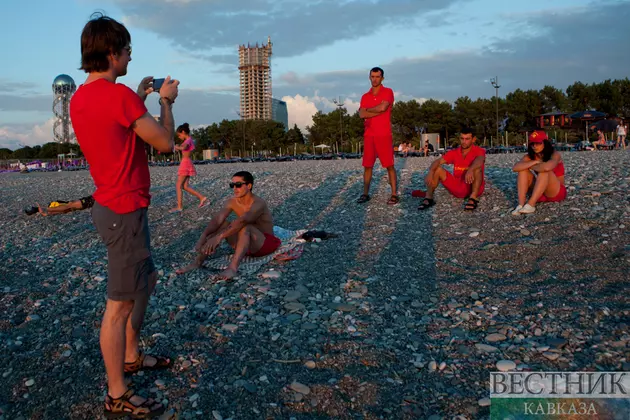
left=0, top=78, right=630, bottom=159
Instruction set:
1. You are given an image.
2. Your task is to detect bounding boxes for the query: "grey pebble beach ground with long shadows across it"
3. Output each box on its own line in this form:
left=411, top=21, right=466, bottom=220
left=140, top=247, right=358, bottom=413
left=0, top=151, right=630, bottom=419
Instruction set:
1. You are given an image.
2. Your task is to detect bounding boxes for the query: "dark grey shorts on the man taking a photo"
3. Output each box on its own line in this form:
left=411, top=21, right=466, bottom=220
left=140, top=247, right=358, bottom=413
left=92, top=203, right=157, bottom=300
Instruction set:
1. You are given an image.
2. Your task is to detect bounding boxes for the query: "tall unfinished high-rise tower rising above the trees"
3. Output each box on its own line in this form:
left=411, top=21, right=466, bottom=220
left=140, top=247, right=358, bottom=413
left=238, top=37, right=272, bottom=120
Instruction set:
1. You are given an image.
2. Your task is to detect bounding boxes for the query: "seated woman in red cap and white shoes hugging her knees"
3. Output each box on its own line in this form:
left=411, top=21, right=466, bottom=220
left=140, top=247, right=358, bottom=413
left=512, top=131, right=567, bottom=215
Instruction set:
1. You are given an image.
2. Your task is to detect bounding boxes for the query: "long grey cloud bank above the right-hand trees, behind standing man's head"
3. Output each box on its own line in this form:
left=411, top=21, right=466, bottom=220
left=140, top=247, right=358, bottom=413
left=274, top=1, right=630, bottom=101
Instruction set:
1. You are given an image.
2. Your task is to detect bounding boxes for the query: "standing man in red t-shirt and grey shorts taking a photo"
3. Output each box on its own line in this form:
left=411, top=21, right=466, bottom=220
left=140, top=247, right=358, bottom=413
left=70, top=14, right=179, bottom=418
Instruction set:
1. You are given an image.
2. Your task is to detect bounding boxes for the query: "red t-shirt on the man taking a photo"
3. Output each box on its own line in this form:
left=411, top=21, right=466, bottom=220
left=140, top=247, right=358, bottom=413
left=70, top=79, right=151, bottom=214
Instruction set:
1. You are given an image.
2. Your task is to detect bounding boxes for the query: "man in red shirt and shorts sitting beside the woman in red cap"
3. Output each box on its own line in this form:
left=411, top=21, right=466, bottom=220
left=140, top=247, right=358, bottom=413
left=418, top=128, right=486, bottom=211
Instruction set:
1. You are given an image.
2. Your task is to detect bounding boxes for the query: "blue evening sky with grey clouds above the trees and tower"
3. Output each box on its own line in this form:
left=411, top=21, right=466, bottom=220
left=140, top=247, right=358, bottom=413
left=0, top=0, right=630, bottom=149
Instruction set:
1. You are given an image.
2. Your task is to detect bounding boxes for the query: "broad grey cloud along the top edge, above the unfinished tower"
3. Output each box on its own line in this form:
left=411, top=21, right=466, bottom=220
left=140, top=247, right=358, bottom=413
left=116, top=0, right=470, bottom=59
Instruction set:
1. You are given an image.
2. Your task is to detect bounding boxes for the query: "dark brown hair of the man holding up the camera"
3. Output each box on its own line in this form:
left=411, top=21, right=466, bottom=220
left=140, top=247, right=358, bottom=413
left=80, top=13, right=131, bottom=73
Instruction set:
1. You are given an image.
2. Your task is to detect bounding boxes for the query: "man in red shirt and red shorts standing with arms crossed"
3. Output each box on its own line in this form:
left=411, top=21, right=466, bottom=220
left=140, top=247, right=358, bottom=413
left=357, top=67, right=400, bottom=204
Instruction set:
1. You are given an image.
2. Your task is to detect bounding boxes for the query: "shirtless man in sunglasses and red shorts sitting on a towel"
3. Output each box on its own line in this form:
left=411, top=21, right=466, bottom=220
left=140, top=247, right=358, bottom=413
left=176, top=171, right=281, bottom=280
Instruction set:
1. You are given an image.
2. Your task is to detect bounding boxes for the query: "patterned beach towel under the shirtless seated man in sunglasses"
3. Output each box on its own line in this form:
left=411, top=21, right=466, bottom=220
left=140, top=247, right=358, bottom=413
left=204, top=226, right=306, bottom=275
